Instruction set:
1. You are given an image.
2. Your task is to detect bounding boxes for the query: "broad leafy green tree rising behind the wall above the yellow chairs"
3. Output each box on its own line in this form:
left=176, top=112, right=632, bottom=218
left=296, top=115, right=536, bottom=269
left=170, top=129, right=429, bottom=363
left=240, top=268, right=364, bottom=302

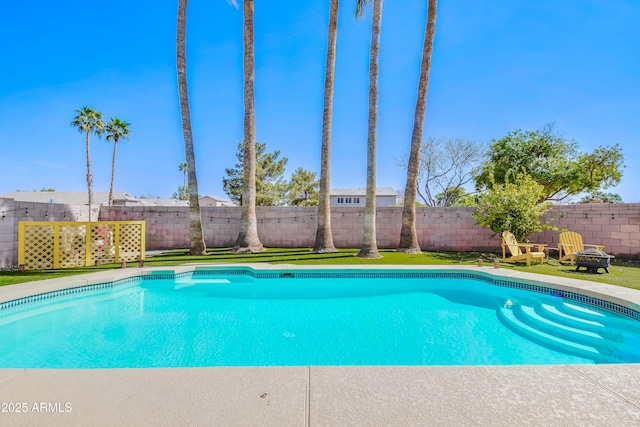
left=475, top=124, right=624, bottom=202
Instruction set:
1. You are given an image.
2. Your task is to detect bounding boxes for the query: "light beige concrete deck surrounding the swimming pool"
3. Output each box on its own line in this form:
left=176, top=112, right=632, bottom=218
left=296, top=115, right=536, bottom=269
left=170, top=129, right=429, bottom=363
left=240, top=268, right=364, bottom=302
left=0, top=265, right=640, bottom=426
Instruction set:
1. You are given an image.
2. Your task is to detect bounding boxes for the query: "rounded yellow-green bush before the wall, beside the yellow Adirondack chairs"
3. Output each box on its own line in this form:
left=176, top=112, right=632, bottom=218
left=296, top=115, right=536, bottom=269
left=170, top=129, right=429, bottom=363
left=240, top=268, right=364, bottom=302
left=473, top=174, right=553, bottom=241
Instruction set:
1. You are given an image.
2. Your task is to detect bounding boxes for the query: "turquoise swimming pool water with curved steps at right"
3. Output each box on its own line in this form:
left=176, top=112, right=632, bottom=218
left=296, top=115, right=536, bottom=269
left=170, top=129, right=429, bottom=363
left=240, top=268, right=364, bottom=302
left=0, top=268, right=640, bottom=368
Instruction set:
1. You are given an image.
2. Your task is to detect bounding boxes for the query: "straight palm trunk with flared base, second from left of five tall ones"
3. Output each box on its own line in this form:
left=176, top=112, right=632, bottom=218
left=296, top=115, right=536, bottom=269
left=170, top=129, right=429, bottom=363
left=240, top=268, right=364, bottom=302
left=232, top=0, right=264, bottom=253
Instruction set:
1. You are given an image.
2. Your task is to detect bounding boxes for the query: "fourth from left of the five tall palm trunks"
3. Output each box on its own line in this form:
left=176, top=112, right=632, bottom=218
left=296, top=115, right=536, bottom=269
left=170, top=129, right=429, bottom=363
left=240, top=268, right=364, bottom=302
left=356, top=0, right=382, bottom=258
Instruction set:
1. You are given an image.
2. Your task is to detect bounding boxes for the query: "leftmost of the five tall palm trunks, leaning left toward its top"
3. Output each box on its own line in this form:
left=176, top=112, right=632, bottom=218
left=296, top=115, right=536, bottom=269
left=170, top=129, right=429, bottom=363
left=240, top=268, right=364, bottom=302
left=176, top=0, right=206, bottom=255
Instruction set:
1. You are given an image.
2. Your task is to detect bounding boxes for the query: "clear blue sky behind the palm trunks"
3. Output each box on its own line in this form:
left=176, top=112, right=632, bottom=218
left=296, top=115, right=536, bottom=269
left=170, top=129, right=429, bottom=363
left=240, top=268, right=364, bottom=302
left=0, top=0, right=640, bottom=202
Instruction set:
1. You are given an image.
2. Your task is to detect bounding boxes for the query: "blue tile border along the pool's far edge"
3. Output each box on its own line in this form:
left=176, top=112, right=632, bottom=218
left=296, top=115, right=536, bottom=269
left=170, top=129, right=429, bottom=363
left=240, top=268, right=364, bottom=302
left=0, top=267, right=640, bottom=321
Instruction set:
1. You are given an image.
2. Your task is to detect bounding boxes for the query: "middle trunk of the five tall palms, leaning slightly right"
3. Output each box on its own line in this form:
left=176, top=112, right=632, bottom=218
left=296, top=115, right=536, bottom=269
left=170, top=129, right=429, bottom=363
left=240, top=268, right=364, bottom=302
left=313, top=0, right=338, bottom=253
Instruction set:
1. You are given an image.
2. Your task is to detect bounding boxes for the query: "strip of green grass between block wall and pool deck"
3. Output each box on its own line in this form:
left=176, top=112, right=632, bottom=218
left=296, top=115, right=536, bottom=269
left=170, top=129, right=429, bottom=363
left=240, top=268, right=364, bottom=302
left=0, top=248, right=640, bottom=289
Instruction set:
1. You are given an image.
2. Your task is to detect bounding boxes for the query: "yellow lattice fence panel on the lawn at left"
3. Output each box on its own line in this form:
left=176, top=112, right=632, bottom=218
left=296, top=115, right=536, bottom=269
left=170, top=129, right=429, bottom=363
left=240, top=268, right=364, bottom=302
left=18, top=221, right=145, bottom=270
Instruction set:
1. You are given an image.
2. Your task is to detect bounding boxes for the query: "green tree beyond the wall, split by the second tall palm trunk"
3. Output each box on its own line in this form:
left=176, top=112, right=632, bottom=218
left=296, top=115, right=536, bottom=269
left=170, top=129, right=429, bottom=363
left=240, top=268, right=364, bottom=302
left=222, top=142, right=289, bottom=206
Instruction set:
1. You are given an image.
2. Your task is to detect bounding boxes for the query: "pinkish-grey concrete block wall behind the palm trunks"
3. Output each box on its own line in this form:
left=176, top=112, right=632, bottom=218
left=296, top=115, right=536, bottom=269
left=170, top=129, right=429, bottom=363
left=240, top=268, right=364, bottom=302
left=0, top=199, right=640, bottom=268
